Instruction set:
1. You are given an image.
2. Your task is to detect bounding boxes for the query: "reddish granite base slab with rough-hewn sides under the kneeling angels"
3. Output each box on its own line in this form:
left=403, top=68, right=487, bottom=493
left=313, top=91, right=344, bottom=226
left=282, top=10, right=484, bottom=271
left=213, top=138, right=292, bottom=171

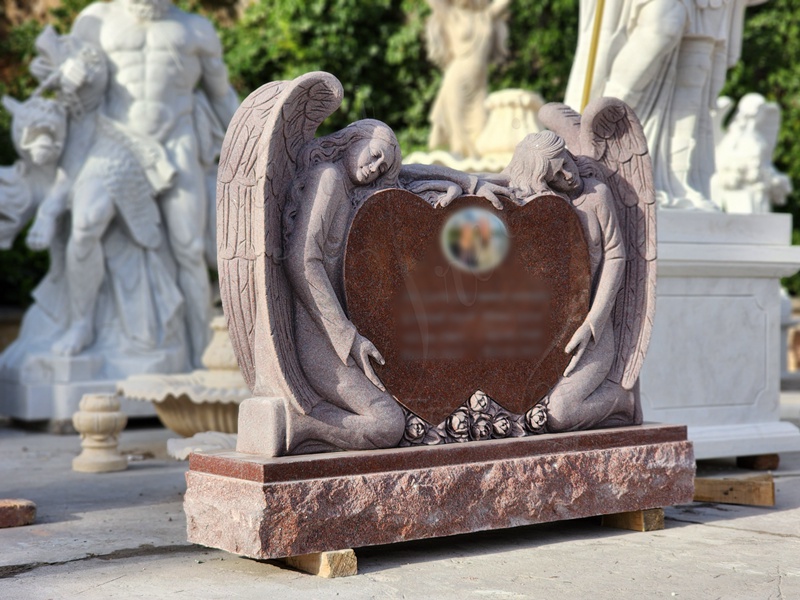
left=184, top=424, right=695, bottom=559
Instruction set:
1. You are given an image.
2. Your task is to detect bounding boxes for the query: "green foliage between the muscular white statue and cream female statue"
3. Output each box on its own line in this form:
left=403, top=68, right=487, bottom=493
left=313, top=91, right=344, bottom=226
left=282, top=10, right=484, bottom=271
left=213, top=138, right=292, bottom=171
left=221, top=0, right=440, bottom=146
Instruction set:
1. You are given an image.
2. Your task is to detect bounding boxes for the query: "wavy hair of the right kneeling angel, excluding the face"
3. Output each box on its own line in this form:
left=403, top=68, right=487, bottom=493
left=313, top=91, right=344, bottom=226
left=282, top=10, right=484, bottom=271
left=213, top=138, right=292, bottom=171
left=503, top=131, right=566, bottom=198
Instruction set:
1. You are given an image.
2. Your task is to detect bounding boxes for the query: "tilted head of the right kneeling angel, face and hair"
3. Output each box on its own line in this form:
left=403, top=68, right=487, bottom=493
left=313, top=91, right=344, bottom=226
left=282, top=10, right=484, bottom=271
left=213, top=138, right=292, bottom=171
left=503, top=131, right=583, bottom=198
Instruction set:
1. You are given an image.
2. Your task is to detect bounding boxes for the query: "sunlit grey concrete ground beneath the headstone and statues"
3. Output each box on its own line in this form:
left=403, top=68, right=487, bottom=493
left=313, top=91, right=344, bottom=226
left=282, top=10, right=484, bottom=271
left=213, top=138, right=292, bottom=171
left=0, top=424, right=800, bottom=600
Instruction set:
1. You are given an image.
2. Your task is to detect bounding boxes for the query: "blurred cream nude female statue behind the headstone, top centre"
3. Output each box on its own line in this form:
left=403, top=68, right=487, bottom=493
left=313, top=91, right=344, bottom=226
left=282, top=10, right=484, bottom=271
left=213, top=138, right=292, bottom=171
left=427, top=0, right=510, bottom=158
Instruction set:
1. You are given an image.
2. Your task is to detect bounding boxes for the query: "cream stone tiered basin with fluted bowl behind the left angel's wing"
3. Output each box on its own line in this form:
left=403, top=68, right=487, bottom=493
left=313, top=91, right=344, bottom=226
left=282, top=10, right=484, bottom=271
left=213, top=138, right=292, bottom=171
left=117, top=316, right=251, bottom=437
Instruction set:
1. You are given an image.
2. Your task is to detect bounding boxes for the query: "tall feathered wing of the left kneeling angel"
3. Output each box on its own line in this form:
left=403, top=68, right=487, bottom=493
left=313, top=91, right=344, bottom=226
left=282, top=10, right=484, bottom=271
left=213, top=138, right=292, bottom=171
left=217, top=72, right=343, bottom=412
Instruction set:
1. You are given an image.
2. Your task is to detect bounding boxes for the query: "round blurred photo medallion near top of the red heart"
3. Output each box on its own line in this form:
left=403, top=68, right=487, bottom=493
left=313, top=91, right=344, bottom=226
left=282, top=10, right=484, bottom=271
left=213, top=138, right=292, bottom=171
left=441, top=207, right=509, bottom=273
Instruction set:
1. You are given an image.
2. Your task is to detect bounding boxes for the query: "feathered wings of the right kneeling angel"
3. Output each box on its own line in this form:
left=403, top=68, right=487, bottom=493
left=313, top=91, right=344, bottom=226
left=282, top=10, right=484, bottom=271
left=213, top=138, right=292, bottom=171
left=539, top=98, right=656, bottom=389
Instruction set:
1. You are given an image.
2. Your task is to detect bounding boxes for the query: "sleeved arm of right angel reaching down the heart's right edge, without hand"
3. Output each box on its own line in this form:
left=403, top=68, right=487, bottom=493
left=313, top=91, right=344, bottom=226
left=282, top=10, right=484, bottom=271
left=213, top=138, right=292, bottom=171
left=586, top=184, right=625, bottom=340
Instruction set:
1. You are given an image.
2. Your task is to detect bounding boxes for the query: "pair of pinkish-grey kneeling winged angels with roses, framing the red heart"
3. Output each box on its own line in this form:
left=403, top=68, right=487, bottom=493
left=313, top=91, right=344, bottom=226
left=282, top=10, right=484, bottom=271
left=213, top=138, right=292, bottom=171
left=217, top=73, right=655, bottom=456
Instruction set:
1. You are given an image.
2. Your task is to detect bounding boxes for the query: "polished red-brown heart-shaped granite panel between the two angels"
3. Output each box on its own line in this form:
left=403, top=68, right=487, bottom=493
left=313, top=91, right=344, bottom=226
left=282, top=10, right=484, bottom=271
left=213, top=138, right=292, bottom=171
left=344, top=189, right=590, bottom=425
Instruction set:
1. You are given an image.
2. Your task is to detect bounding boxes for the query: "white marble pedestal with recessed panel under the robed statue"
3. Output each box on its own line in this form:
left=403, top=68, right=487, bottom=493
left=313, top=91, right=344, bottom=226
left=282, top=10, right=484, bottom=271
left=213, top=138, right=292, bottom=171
left=641, top=210, right=800, bottom=458
